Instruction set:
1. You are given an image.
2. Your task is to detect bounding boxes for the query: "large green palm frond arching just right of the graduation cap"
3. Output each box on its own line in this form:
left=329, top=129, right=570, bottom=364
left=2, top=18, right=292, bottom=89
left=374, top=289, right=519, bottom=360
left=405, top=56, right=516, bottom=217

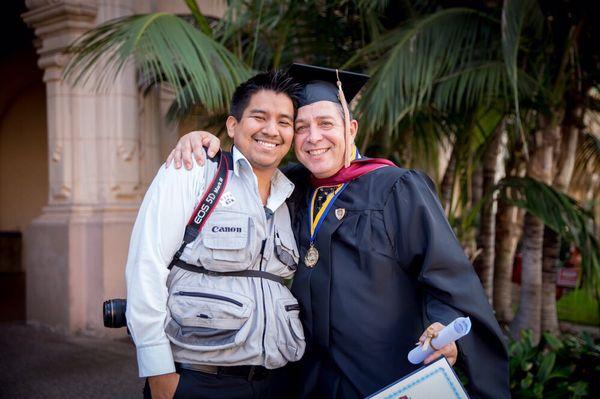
left=349, top=8, right=500, bottom=134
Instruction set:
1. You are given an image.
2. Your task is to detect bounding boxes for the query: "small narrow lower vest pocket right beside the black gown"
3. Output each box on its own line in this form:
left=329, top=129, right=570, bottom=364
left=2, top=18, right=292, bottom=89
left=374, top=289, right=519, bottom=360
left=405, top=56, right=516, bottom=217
left=277, top=298, right=306, bottom=362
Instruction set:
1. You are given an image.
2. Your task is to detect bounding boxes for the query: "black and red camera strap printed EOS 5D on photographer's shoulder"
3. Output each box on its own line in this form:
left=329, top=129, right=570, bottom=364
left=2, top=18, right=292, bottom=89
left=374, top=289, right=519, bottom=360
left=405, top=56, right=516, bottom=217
left=168, top=150, right=233, bottom=270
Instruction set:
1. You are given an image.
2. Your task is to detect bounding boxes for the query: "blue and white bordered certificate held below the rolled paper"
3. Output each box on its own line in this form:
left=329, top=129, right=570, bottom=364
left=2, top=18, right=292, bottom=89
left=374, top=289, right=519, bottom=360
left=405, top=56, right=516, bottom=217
left=367, top=356, right=469, bottom=399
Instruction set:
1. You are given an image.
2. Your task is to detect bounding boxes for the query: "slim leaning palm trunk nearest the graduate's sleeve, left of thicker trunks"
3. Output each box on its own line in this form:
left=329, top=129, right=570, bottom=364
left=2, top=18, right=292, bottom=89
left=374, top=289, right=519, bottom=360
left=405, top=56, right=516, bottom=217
left=474, top=123, right=504, bottom=302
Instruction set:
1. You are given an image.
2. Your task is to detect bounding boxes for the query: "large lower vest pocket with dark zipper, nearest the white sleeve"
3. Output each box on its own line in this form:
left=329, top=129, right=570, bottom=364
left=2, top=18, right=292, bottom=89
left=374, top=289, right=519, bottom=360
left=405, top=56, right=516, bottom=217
left=165, top=287, right=254, bottom=351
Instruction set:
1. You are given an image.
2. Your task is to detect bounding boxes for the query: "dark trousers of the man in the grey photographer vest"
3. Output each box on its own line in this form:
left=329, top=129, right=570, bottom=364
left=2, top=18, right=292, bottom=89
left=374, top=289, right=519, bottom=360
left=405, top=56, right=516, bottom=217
left=144, top=367, right=287, bottom=399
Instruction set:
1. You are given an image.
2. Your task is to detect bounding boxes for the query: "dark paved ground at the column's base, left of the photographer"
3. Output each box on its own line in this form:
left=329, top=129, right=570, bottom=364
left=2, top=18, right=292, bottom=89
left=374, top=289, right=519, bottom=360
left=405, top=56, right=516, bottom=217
left=0, top=322, right=143, bottom=399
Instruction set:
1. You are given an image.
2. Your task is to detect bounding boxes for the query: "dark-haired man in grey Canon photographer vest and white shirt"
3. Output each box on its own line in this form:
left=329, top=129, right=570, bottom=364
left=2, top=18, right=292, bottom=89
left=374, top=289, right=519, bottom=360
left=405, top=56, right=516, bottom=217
left=126, top=72, right=305, bottom=398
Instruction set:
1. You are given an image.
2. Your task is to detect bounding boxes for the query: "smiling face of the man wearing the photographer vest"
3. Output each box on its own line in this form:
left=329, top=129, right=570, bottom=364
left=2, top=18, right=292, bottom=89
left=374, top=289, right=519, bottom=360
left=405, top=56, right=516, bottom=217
left=226, top=90, right=294, bottom=171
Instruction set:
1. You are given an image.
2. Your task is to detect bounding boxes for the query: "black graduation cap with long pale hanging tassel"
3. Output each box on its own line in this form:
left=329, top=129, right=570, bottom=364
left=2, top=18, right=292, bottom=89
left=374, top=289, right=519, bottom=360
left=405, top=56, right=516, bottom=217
left=288, top=64, right=369, bottom=167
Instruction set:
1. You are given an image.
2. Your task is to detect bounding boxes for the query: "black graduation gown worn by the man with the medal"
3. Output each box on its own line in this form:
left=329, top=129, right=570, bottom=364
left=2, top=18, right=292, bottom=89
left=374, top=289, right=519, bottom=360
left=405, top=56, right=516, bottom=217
left=286, top=166, right=510, bottom=398
